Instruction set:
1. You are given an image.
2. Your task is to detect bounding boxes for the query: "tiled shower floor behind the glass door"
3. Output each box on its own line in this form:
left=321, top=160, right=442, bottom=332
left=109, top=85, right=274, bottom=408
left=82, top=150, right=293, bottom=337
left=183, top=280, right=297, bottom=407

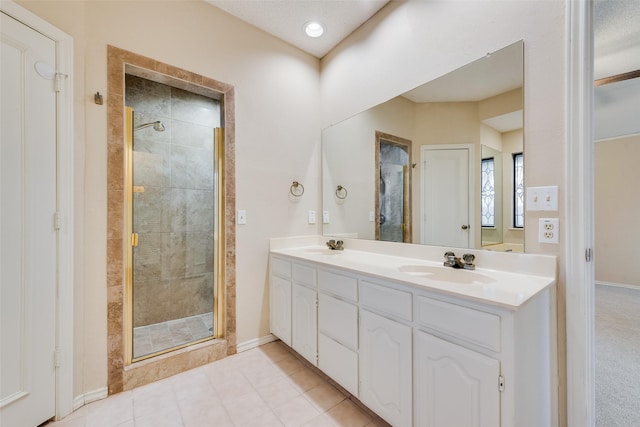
left=133, top=313, right=213, bottom=358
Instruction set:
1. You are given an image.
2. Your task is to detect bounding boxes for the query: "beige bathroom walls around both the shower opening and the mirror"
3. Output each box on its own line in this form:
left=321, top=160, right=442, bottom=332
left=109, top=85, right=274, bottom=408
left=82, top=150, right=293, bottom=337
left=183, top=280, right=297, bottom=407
left=19, top=0, right=566, bottom=424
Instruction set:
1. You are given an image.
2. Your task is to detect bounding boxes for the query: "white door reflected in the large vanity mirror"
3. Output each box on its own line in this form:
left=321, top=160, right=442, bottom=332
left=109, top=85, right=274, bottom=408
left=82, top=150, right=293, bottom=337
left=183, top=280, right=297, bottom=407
left=422, top=145, right=473, bottom=248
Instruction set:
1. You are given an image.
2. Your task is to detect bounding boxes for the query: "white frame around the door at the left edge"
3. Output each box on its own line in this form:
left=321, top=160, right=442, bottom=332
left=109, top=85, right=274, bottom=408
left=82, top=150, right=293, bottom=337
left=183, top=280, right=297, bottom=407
left=0, top=0, right=74, bottom=419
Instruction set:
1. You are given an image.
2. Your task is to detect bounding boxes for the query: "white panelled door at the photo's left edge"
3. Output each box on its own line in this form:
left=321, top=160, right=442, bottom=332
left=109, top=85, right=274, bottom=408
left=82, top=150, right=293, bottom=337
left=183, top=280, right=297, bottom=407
left=0, top=13, right=57, bottom=427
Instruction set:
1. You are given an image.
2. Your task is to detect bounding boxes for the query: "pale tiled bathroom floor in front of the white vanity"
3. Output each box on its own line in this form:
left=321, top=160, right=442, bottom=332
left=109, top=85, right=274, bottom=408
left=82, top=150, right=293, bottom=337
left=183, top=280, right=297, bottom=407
left=47, top=341, right=387, bottom=427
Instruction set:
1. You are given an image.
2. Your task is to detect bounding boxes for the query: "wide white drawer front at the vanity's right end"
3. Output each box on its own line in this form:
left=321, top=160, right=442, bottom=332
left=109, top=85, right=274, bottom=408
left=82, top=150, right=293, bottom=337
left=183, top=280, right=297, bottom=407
left=416, top=296, right=501, bottom=351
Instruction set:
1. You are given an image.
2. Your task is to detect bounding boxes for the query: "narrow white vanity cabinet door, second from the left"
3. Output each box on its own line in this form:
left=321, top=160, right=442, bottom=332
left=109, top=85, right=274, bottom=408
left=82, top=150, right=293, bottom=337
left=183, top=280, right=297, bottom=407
left=291, top=284, right=318, bottom=366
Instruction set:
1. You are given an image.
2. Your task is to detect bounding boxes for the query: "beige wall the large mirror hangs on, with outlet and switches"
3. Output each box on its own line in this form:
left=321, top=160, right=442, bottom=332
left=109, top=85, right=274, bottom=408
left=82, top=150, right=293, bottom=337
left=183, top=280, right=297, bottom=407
left=321, top=0, right=567, bottom=425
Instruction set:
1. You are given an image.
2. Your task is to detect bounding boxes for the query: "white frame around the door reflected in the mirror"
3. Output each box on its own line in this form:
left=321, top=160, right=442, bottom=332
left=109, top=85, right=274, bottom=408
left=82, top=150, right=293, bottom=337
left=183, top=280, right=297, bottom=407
left=419, top=144, right=479, bottom=249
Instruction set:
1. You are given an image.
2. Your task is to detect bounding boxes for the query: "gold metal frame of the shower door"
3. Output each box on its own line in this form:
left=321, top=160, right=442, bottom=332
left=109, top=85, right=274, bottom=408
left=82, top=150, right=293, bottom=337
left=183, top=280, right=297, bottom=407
left=123, top=107, right=225, bottom=365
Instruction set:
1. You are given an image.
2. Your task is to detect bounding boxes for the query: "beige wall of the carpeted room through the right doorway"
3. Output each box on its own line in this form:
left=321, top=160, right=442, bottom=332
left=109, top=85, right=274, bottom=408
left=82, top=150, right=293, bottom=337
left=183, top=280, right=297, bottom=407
left=594, top=134, right=640, bottom=288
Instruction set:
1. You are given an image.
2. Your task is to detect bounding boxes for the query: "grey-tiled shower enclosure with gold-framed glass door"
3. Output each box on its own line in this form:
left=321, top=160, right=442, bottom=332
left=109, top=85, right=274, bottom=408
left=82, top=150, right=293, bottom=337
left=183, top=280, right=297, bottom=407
left=125, top=74, right=222, bottom=362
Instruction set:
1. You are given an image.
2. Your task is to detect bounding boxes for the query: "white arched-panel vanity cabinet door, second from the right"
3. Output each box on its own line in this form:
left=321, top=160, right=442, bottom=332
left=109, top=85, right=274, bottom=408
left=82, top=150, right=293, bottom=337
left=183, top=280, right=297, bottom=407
left=360, top=310, right=410, bottom=426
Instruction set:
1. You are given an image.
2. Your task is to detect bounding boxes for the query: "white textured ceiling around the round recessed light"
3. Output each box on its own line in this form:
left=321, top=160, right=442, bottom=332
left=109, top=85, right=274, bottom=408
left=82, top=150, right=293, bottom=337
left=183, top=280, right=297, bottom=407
left=205, top=0, right=389, bottom=58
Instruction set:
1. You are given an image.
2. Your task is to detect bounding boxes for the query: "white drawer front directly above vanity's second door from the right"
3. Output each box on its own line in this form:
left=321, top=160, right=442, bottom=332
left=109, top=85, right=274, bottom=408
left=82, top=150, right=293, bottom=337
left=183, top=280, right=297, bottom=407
left=360, top=280, right=412, bottom=321
